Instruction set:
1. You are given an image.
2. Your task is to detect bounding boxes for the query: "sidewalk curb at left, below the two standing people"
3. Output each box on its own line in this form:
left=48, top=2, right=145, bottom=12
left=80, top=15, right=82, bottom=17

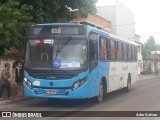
left=0, top=97, right=30, bottom=105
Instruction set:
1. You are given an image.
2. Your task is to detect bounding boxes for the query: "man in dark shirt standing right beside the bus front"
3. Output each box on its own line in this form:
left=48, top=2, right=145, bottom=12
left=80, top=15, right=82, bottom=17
left=12, top=56, right=24, bottom=97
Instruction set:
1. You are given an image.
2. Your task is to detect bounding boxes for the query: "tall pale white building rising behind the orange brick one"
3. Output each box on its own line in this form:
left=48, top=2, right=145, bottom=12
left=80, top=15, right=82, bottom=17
left=97, top=0, right=135, bottom=41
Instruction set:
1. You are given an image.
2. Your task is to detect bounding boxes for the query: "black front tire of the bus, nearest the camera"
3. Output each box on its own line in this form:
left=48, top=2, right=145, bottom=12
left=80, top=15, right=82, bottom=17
left=96, top=80, right=106, bottom=103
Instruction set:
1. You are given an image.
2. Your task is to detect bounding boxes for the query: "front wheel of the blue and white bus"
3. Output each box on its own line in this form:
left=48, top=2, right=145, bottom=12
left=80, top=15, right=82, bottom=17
left=96, top=81, right=104, bottom=103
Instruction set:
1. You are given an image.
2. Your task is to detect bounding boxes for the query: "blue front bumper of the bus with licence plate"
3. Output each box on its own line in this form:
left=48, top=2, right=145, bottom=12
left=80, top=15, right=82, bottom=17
left=23, top=83, right=89, bottom=99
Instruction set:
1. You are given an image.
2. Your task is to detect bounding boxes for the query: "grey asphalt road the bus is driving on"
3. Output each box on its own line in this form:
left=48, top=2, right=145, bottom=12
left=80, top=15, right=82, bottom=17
left=0, top=77, right=160, bottom=120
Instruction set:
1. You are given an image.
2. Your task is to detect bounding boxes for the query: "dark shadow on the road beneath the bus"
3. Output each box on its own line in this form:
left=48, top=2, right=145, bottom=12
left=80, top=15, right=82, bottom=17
left=25, top=89, right=130, bottom=108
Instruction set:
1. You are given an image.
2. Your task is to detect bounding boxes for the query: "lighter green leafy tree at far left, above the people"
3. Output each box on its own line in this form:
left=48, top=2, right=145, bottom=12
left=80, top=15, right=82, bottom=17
left=0, top=0, right=32, bottom=54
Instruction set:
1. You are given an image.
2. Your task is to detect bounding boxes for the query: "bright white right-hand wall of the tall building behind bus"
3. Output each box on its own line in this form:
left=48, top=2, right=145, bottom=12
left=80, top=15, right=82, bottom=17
left=115, top=1, right=135, bottom=41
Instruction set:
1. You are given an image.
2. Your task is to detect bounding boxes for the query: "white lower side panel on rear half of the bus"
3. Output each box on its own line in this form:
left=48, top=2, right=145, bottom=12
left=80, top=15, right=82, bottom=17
left=109, top=62, right=138, bottom=92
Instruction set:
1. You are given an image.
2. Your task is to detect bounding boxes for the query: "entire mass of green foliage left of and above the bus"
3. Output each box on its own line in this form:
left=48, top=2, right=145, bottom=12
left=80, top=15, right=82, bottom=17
left=0, top=0, right=97, bottom=53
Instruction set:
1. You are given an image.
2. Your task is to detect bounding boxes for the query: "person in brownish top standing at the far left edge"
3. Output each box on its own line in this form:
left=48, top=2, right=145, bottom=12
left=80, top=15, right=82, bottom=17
left=0, top=63, right=11, bottom=100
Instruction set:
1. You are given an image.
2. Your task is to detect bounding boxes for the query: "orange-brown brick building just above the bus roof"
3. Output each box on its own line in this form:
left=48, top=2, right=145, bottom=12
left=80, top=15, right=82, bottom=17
left=73, top=15, right=112, bottom=33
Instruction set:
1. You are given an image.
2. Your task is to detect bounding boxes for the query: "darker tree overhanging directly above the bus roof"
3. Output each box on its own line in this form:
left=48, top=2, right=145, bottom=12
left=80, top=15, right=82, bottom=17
left=19, top=0, right=97, bottom=23
